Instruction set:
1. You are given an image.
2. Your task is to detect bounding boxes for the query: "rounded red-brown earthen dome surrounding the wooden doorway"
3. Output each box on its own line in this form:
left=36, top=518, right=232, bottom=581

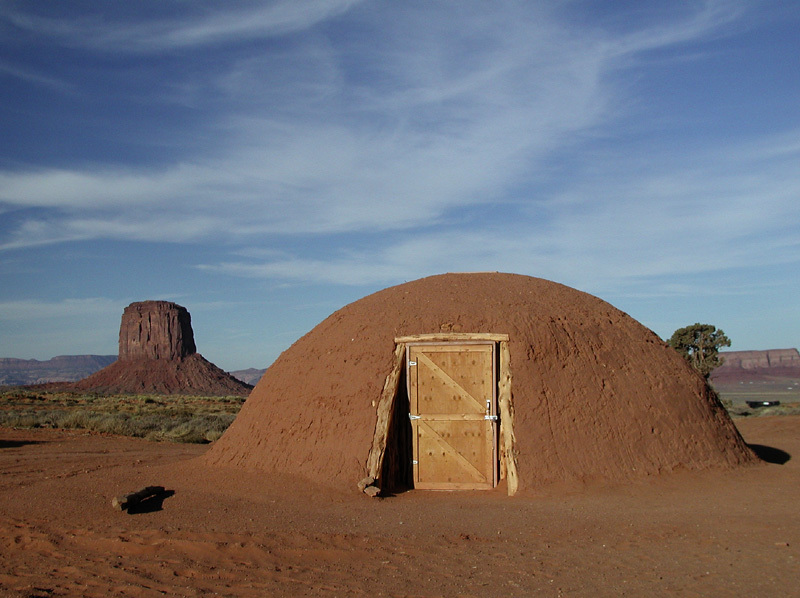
left=206, top=273, right=755, bottom=490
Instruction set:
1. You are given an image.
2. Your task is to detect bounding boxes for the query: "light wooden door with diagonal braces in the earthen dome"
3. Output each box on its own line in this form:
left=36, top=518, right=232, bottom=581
left=407, top=343, right=497, bottom=490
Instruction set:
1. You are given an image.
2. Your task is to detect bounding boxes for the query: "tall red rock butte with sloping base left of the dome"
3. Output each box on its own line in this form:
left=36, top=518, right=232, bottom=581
left=70, top=301, right=252, bottom=396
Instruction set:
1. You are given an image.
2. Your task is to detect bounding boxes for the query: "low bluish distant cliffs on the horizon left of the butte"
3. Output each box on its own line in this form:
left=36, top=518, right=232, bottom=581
left=0, top=355, right=117, bottom=386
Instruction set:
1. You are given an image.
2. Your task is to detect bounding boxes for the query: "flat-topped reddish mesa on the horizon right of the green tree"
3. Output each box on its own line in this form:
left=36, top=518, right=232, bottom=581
left=711, top=349, right=800, bottom=384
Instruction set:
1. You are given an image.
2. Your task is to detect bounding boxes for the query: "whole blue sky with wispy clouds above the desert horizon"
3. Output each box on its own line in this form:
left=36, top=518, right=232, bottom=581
left=0, top=0, right=800, bottom=370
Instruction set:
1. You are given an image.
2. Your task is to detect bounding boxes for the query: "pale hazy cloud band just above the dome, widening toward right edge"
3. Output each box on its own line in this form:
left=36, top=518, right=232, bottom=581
left=200, top=126, right=800, bottom=294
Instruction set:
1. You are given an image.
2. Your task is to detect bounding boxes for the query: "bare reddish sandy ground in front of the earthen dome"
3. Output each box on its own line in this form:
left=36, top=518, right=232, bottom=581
left=0, top=416, right=800, bottom=598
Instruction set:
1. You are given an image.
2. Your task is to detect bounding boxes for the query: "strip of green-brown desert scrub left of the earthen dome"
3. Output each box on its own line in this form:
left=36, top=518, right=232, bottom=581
left=0, top=389, right=245, bottom=443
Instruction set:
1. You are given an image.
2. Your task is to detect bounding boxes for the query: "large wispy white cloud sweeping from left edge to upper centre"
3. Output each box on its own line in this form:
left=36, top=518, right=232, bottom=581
left=0, top=11, right=607, bottom=247
